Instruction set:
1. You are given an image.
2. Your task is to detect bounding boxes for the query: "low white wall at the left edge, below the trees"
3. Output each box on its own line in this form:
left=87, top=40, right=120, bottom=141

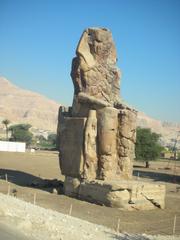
left=0, top=141, right=26, bottom=152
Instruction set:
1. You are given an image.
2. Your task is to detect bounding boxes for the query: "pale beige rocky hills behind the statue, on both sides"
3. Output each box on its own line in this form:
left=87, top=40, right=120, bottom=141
left=0, top=77, right=180, bottom=147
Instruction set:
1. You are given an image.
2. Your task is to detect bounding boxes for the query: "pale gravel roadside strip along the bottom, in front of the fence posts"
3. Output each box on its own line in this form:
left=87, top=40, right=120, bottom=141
left=0, top=193, right=180, bottom=240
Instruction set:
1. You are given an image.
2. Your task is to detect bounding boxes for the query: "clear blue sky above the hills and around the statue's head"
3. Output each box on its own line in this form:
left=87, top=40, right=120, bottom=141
left=0, top=0, right=180, bottom=122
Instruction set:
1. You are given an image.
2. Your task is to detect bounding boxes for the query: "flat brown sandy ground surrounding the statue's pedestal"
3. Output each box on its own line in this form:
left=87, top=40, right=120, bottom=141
left=0, top=152, right=180, bottom=239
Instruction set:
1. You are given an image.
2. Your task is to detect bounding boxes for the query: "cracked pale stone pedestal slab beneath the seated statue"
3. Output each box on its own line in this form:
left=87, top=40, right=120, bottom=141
left=64, top=177, right=166, bottom=210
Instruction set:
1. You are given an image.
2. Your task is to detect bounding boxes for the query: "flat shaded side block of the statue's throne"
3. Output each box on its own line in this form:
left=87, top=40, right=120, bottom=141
left=59, top=117, right=86, bottom=177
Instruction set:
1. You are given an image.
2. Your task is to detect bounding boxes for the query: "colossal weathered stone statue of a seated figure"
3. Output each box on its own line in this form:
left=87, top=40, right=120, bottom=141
left=57, top=28, right=165, bottom=207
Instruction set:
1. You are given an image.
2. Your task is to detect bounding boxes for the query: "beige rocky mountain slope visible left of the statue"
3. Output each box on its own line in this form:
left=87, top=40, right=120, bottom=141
left=0, top=77, right=60, bottom=132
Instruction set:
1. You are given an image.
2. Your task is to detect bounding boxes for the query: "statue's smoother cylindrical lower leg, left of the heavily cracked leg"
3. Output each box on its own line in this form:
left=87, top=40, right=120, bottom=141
left=97, top=107, right=118, bottom=179
